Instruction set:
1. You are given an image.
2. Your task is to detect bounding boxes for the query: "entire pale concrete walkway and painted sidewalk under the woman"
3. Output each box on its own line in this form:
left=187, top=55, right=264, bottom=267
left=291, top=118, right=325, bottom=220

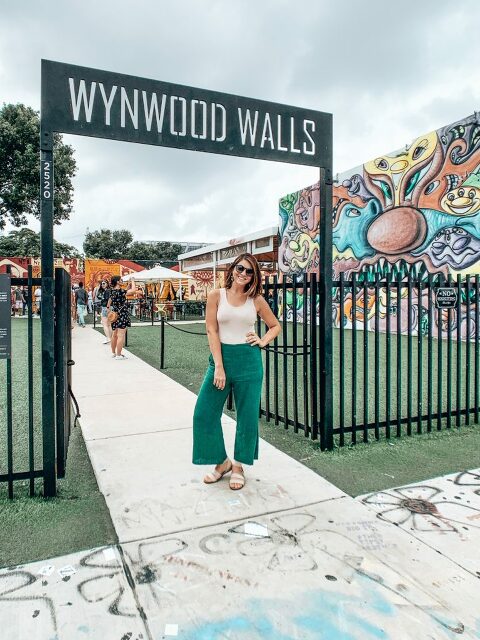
left=0, top=328, right=480, bottom=640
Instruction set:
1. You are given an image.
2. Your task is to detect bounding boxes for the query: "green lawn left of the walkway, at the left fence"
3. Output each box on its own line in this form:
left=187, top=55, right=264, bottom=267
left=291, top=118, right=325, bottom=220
left=0, top=318, right=116, bottom=567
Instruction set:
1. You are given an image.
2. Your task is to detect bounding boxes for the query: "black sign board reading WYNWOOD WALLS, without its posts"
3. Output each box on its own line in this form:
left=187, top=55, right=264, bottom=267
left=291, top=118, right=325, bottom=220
left=42, top=60, right=332, bottom=167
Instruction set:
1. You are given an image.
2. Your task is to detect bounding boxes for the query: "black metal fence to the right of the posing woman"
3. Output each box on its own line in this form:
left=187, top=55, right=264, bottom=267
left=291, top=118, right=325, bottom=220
left=258, top=274, right=480, bottom=448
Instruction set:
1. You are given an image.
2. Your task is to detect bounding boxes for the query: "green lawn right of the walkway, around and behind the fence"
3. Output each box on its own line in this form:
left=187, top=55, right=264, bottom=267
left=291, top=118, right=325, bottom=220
left=121, top=324, right=480, bottom=496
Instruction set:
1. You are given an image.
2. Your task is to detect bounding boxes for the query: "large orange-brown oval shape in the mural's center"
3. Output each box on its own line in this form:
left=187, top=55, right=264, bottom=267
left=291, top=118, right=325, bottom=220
left=367, top=207, right=427, bottom=255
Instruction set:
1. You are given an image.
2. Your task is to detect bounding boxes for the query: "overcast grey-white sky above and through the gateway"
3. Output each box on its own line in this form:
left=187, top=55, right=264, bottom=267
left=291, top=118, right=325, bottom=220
left=0, top=0, right=480, bottom=248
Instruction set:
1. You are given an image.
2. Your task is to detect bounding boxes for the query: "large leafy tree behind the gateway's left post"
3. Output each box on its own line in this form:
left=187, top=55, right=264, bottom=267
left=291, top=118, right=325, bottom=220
left=0, top=104, right=77, bottom=229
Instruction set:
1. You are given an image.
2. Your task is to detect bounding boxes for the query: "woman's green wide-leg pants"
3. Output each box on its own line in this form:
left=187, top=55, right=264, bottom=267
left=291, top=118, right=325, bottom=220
left=193, top=343, right=263, bottom=464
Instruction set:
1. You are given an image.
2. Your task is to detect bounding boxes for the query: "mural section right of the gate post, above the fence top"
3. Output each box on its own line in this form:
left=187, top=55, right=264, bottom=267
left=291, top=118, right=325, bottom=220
left=333, top=114, right=480, bottom=278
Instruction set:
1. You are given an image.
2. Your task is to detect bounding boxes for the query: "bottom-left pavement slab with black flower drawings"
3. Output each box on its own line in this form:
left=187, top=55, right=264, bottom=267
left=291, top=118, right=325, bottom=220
left=0, top=547, right=146, bottom=640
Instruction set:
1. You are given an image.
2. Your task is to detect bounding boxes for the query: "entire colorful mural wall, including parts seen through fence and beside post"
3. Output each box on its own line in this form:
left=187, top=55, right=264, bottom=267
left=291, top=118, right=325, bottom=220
left=279, top=113, right=480, bottom=335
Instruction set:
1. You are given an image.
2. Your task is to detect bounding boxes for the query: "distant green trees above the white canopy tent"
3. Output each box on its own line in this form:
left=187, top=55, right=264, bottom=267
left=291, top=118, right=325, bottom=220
left=83, top=229, right=182, bottom=263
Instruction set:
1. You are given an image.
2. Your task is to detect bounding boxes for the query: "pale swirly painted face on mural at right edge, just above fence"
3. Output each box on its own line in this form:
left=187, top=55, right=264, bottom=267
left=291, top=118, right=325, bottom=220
left=426, top=227, right=480, bottom=269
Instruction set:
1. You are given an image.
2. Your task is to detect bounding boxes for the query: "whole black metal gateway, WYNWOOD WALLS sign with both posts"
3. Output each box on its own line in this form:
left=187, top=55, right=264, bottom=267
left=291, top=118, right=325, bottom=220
left=40, top=60, right=333, bottom=495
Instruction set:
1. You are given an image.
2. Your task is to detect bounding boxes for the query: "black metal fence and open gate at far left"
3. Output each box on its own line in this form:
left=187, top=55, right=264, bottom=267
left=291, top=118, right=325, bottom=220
left=0, top=266, right=72, bottom=498
